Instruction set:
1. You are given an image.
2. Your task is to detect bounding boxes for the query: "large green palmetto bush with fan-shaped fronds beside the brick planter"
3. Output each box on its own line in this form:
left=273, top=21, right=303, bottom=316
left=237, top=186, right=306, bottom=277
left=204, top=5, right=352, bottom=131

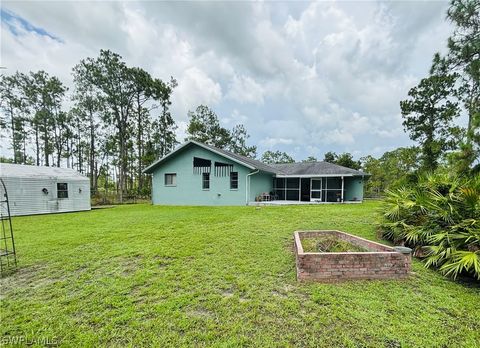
left=379, top=173, right=480, bottom=279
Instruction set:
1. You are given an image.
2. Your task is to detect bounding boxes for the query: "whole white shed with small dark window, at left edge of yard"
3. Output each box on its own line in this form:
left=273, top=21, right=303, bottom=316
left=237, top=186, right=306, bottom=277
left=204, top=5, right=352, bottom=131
left=0, top=163, right=91, bottom=216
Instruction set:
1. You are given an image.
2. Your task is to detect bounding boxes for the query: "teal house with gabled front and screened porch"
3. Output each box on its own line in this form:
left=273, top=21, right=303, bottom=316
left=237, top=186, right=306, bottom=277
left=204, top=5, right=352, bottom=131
left=144, top=141, right=368, bottom=205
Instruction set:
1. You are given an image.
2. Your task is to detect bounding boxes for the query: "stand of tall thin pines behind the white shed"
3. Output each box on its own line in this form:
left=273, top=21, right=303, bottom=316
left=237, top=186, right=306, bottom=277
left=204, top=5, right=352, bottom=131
left=0, top=50, right=178, bottom=201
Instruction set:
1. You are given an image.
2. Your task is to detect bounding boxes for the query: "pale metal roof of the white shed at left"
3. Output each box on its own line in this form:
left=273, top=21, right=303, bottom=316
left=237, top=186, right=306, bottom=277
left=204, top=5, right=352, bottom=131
left=0, top=163, right=88, bottom=180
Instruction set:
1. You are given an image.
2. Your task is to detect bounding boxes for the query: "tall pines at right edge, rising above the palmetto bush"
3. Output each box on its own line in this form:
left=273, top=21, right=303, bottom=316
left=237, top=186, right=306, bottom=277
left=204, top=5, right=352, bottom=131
left=400, top=0, right=480, bottom=176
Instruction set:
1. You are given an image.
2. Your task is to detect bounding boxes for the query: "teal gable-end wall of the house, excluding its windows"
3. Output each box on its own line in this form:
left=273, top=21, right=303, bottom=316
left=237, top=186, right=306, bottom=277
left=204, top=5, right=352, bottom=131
left=152, top=145, right=272, bottom=205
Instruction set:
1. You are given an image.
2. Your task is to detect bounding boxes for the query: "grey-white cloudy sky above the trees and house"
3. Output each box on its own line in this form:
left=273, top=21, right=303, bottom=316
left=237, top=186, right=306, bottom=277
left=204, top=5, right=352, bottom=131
left=0, top=1, right=451, bottom=160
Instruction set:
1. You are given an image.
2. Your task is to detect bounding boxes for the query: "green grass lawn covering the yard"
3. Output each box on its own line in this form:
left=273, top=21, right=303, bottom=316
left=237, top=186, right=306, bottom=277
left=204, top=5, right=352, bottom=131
left=0, top=202, right=480, bottom=347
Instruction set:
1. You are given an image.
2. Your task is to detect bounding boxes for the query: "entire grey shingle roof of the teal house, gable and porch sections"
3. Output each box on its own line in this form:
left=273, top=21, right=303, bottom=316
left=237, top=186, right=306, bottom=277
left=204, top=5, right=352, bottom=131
left=144, top=140, right=368, bottom=176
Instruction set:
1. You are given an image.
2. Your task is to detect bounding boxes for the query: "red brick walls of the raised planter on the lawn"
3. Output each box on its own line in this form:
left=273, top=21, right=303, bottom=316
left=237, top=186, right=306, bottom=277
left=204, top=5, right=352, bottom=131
left=294, top=231, right=412, bottom=282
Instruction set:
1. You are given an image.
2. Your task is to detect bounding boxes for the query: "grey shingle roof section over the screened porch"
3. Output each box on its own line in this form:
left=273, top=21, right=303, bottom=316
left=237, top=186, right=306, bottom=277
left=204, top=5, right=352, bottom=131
left=272, top=162, right=368, bottom=176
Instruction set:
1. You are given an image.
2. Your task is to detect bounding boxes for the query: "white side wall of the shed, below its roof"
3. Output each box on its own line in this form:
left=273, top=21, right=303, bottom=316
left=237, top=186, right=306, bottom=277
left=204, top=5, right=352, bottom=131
left=2, top=177, right=91, bottom=216
